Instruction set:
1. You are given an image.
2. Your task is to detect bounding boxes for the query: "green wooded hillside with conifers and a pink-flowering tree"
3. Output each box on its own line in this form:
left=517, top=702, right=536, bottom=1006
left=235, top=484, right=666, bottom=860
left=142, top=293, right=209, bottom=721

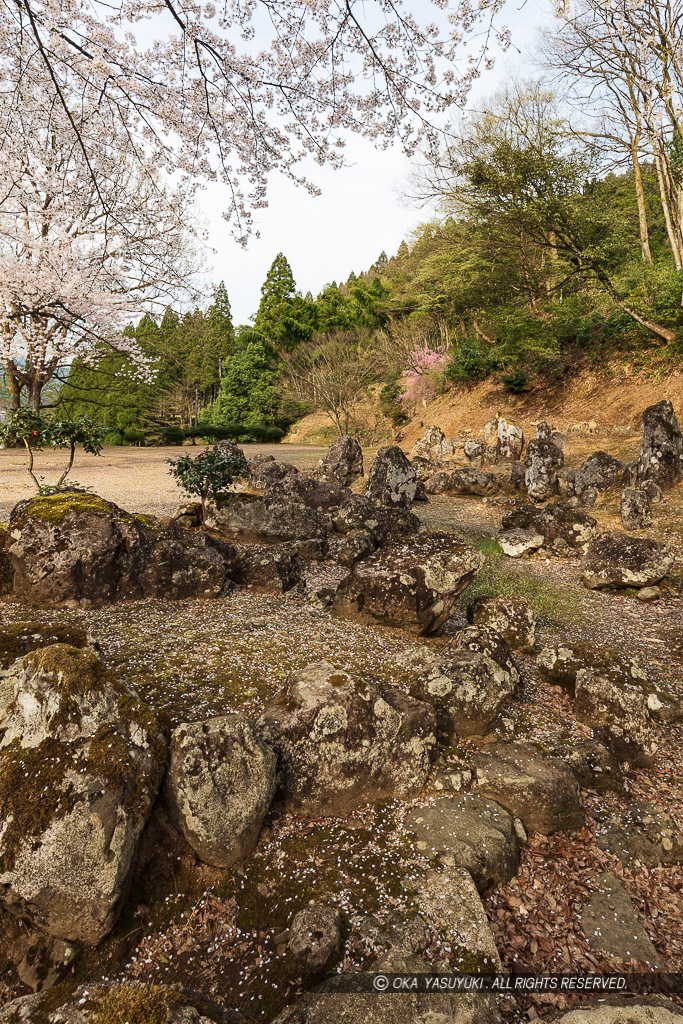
left=55, top=81, right=683, bottom=443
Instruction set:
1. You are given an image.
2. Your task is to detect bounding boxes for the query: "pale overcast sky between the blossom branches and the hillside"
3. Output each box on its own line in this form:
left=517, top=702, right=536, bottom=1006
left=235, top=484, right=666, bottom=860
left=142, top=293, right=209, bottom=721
left=199, top=0, right=550, bottom=325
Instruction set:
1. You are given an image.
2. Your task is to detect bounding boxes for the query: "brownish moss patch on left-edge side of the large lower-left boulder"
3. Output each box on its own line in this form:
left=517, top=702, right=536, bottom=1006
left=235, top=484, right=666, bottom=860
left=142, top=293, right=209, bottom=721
left=0, top=738, right=77, bottom=871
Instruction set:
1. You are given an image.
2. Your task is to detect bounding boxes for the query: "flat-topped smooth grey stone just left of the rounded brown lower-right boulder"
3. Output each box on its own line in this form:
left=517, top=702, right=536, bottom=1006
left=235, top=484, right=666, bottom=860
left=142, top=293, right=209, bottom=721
left=403, top=794, right=519, bottom=892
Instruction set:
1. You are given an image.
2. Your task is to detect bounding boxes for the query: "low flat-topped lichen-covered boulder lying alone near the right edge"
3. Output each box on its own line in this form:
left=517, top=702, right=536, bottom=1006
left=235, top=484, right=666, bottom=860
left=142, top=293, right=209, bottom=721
left=581, top=530, right=674, bottom=590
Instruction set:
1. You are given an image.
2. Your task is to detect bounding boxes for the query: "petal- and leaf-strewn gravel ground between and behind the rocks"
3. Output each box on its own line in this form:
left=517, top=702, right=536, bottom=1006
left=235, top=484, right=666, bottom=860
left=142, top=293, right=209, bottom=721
left=0, top=445, right=683, bottom=1022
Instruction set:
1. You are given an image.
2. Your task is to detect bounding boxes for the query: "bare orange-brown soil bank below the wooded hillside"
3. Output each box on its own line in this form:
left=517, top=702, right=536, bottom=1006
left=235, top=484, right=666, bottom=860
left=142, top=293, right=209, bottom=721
left=400, top=365, right=683, bottom=449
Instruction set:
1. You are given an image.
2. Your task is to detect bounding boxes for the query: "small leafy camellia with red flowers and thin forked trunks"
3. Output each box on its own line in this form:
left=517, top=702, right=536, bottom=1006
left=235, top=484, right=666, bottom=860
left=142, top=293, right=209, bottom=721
left=0, top=409, right=103, bottom=493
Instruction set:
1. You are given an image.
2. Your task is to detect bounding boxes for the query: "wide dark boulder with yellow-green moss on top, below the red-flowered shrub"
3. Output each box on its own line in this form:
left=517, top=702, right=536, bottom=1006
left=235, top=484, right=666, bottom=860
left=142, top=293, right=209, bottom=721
left=5, top=492, right=234, bottom=607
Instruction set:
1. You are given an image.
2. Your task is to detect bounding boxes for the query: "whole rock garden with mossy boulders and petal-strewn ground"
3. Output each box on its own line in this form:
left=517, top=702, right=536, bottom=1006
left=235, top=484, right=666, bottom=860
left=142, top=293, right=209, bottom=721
left=0, top=400, right=683, bottom=1024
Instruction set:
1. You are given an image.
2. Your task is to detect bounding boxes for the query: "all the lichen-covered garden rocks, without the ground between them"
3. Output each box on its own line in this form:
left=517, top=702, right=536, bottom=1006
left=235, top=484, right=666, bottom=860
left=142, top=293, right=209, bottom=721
left=0, top=401, right=683, bottom=1024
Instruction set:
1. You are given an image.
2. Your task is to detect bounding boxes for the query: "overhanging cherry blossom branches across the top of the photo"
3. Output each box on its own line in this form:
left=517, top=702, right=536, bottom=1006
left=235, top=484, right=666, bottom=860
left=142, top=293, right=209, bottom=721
left=0, top=0, right=508, bottom=240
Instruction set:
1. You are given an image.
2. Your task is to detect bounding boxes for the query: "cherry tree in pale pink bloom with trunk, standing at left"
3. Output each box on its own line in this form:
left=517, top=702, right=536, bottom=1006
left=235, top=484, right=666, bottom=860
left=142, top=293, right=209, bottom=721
left=0, top=89, right=194, bottom=412
